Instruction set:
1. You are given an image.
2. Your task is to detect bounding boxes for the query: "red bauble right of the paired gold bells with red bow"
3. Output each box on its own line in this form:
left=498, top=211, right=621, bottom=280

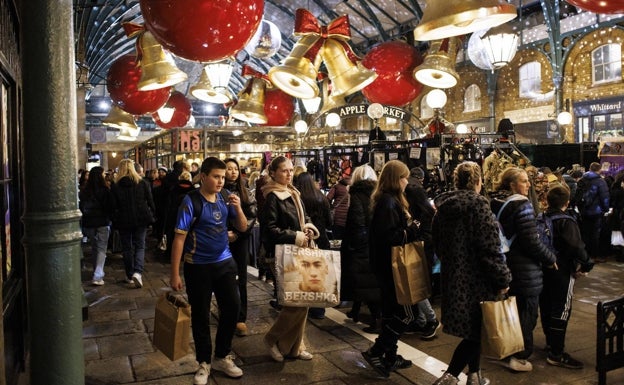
left=362, top=41, right=423, bottom=107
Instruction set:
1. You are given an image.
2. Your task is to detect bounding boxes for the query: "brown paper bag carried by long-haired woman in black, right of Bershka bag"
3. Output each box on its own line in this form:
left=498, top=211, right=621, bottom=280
left=392, top=241, right=431, bottom=305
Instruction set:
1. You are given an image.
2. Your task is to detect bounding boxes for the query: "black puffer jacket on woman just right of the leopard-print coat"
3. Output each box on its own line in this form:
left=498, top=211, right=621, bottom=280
left=490, top=191, right=557, bottom=296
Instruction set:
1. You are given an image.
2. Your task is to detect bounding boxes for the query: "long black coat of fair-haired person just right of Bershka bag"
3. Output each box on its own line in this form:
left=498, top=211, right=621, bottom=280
left=340, top=180, right=381, bottom=303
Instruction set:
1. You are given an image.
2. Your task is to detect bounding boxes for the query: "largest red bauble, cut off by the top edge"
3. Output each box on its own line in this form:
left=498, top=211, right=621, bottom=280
left=140, top=0, right=264, bottom=62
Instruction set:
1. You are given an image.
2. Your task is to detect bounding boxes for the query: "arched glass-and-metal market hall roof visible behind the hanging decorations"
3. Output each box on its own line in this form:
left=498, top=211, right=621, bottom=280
left=74, top=0, right=539, bottom=94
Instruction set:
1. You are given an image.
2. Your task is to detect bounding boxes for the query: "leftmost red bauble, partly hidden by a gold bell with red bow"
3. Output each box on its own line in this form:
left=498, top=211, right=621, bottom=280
left=106, top=55, right=171, bottom=115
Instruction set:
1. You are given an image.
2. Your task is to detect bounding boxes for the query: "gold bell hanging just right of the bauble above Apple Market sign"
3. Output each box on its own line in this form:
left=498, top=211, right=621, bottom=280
left=414, top=37, right=459, bottom=88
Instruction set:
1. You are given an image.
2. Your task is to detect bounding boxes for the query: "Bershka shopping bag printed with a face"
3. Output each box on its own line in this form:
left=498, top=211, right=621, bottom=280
left=275, top=245, right=340, bottom=307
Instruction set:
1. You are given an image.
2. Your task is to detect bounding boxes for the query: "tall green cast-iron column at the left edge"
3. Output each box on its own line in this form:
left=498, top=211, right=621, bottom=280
left=20, top=0, right=84, bottom=385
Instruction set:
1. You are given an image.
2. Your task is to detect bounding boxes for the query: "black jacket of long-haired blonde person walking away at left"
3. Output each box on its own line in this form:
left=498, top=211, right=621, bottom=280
left=111, top=176, right=155, bottom=229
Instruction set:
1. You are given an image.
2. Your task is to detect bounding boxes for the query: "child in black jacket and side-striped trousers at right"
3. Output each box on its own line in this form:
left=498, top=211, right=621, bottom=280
left=540, top=186, right=594, bottom=369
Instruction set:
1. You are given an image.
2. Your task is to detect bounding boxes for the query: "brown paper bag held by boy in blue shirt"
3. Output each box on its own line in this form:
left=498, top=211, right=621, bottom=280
left=154, top=292, right=191, bottom=361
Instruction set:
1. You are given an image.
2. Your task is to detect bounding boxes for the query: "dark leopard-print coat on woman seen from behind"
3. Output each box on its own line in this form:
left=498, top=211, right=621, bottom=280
left=433, top=190, right=511, bottom=341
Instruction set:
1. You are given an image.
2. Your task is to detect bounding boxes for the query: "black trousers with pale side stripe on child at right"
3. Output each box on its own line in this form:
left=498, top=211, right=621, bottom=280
left=540, top=269, right=576, bottom=355
